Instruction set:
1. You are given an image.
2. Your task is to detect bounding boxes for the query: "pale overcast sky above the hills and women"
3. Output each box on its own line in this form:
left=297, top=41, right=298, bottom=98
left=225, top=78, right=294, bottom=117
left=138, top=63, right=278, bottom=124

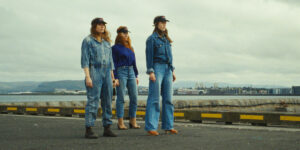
left=0, top=0, right=300, bottom=86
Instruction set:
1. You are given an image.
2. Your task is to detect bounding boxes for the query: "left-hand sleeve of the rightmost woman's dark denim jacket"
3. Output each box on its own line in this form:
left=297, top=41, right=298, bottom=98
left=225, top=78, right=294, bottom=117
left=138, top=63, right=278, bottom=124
left=146, top=36, right=154, bottom=74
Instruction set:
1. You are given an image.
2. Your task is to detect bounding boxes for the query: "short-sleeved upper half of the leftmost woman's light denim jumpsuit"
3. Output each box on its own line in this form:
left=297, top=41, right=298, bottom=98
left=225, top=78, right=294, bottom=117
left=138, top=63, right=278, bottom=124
left=81, top=35, right=115, bottom=70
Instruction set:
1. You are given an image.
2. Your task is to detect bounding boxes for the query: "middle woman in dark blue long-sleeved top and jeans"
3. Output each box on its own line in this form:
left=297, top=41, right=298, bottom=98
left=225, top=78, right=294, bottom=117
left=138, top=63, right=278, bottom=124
left=112, top=26, right=140, bottom=130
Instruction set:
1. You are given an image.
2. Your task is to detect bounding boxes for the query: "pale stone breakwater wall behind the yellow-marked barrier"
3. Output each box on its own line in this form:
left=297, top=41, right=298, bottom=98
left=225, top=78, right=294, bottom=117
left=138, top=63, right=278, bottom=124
left=0, top=97, right=300, bottom=112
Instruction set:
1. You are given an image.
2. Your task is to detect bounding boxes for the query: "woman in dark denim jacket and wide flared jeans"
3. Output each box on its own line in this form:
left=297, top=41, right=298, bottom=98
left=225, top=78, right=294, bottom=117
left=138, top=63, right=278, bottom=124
left=145, top=16, right=178, bottom=136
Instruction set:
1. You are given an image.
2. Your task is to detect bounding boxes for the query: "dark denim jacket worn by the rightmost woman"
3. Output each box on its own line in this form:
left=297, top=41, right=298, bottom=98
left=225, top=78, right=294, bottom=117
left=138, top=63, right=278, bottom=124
left=146, top=32, right=175, bottom=74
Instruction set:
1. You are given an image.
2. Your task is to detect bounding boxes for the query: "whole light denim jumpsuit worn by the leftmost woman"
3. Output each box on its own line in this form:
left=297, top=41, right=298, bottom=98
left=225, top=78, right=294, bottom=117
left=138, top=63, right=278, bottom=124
left=81, top=35, right=114, bottom=127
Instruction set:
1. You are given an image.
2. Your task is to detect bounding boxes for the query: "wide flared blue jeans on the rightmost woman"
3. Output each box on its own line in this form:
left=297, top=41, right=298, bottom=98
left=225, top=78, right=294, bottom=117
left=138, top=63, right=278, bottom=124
left=145, top=63, right=174, bottom=131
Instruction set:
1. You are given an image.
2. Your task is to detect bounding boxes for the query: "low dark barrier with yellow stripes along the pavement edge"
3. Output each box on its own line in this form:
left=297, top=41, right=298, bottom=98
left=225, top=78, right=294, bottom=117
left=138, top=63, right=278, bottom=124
left=0, top=106, right=300, bottom=126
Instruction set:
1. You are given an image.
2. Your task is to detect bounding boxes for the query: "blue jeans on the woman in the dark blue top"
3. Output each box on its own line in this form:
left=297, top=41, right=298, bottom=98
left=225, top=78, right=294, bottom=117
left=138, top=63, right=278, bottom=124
left=116, top=66, right=137, bottom=118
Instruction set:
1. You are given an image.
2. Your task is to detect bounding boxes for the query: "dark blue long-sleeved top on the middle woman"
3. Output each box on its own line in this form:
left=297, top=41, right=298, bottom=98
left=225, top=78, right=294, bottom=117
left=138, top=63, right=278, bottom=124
left=112, top=44, right=139, bottom=79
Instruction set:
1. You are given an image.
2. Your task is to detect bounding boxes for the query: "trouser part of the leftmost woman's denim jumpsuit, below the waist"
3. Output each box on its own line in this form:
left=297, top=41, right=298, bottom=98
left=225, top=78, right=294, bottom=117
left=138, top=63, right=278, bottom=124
left=85, top=66, right=113, bottom=127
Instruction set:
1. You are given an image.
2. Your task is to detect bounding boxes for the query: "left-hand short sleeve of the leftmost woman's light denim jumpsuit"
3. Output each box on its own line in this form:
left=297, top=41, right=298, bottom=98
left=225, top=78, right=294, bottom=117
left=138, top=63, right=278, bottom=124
left=81, top=39, right=90, bottom=68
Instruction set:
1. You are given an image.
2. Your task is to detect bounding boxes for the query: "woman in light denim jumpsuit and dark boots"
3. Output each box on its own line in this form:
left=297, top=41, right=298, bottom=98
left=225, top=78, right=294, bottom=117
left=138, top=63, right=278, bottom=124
left=81, top=18, right=116, bottom=138
